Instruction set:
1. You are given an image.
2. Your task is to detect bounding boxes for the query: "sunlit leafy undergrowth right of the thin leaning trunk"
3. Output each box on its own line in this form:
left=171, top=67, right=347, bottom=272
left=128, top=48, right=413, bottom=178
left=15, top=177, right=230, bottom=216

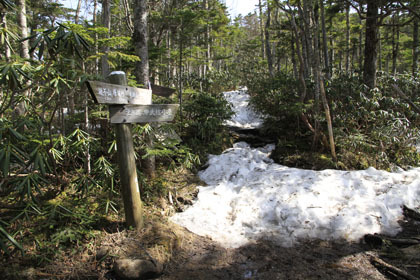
left=327, top=74, right=420, bottom=169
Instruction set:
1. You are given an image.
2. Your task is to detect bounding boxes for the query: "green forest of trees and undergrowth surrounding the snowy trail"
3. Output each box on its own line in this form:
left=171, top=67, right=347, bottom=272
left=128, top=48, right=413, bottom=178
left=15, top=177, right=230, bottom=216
left=0, top=0, right=420, bottom=279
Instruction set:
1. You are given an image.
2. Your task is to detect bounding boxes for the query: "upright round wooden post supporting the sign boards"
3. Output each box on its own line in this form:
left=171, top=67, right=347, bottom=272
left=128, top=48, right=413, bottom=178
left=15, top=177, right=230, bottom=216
left=108, top=72, right=143, bottom=229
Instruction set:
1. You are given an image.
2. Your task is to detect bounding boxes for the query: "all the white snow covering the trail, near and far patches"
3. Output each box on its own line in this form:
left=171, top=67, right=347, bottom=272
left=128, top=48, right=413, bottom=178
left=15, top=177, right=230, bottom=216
left=171, top=88, right=420, bottom=248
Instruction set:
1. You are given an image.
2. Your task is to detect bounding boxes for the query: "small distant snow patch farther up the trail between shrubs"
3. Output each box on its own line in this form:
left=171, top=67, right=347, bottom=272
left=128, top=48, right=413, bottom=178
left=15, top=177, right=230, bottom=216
left=223, top=88, right=263, bottom=129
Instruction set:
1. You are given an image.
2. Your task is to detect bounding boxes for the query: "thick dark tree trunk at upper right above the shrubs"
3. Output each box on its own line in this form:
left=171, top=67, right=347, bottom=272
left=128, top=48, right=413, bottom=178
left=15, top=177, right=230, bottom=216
left=363, top=0, right=379, bottom=88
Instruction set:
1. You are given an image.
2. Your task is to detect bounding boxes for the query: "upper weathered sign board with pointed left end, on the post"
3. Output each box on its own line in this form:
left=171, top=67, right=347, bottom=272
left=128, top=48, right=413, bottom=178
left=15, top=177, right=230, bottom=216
left=87, top=81, right=152, bottom=105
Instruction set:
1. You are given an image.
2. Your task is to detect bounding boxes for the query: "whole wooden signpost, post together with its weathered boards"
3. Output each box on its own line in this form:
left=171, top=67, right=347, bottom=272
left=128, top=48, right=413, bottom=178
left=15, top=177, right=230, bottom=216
left=87, top=71, right=179, bottom=229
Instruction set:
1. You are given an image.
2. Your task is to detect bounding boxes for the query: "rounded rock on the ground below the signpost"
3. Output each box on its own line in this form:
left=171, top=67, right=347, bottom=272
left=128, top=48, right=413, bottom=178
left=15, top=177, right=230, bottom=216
left=114, top=258, right=163, bottom=280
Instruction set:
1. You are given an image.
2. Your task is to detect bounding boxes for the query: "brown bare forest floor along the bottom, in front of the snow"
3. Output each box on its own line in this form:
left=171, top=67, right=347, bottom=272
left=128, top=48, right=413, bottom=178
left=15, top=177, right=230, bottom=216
left=0, top=165, right=420, bottom=280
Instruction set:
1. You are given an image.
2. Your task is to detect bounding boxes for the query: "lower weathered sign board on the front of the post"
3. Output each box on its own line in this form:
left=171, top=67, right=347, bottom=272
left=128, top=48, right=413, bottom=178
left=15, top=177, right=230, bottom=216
left=109, top=104, right=179, bottom=123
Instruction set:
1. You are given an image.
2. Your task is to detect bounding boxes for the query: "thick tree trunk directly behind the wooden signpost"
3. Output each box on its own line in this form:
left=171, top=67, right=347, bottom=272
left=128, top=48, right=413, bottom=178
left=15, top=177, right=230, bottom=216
left=133, top=0, right=156, bottom=178
